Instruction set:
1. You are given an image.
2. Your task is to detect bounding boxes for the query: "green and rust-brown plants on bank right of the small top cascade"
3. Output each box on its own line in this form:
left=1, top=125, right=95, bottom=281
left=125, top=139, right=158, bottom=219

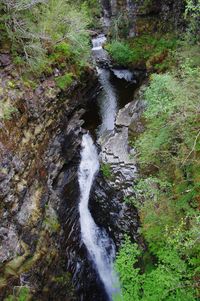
left=105, top=34, right=177, bottom=71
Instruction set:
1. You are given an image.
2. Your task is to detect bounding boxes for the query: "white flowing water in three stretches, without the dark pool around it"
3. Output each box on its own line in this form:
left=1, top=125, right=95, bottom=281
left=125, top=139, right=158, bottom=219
left=78, top=35, right=120, bottom=301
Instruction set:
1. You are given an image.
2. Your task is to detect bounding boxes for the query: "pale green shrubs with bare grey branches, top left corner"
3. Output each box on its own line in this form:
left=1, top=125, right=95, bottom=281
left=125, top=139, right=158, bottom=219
left=0, top=0, right=90, bottom=75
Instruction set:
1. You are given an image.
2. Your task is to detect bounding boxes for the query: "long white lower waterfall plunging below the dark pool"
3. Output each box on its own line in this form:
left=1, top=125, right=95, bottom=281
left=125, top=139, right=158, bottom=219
left=78, top=134, right=120, bottom=300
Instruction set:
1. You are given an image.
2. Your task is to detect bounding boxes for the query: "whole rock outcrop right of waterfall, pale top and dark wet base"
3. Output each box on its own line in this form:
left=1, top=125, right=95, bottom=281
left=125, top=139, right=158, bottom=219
left=89, top=96, right=144, bottom=249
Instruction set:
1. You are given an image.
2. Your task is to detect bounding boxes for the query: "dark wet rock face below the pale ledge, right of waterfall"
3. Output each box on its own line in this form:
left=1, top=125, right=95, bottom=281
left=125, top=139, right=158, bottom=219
left=89, top=173, right=140, bottom=250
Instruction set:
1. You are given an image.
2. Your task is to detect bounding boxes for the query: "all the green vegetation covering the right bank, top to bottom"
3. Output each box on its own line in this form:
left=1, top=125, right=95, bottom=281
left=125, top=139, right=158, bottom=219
left=115, top=0, right=200, bottom=301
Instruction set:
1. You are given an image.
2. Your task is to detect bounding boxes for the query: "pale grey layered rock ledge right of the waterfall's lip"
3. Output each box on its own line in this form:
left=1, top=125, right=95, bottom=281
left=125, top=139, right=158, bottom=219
left=98, top=100, right=143, bottom=197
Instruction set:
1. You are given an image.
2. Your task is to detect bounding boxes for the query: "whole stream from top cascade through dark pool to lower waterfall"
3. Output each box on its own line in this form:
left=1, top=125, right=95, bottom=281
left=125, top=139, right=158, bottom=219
left=78, top=34, right=139, bottom=301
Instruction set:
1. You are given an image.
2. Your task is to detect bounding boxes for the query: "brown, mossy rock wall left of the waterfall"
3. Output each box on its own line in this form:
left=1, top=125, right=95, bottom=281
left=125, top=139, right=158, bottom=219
left=0, top=60, right=103, bottom=301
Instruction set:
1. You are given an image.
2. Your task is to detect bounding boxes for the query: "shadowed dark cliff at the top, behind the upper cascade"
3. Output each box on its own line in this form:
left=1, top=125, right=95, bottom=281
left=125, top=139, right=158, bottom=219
left=104, top=0, right=184, bottom=37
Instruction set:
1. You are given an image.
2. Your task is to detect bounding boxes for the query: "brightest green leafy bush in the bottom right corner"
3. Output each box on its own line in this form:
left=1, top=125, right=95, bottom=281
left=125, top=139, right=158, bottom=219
left=114, top=237, right=198, bottom=301
